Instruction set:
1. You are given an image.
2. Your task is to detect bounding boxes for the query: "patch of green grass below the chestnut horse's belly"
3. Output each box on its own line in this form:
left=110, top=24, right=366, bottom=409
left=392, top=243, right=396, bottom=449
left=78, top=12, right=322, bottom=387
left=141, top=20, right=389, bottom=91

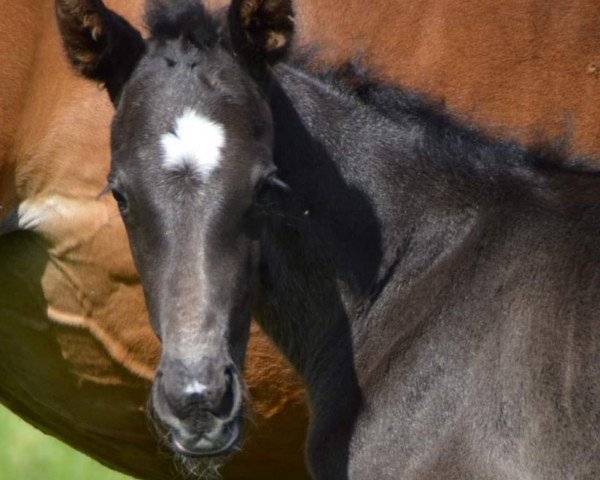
left=0, top=405, right=131, bottom=480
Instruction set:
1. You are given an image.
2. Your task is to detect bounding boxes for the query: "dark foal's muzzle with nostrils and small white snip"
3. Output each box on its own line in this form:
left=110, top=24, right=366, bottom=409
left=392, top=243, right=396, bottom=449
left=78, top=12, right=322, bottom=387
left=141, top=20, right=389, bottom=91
left=151, top=359, right=242, bottom=457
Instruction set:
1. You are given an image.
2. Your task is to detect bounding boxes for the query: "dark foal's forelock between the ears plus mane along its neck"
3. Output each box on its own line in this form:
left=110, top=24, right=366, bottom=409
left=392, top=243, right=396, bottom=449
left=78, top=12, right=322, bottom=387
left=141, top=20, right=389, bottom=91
left=145, top=0, right=600, bottom=177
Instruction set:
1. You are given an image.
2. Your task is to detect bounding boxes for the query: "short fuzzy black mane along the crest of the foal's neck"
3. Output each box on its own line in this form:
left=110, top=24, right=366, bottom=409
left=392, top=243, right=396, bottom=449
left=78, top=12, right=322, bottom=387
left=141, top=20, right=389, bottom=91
left=289, top=55, right=600, bottom=180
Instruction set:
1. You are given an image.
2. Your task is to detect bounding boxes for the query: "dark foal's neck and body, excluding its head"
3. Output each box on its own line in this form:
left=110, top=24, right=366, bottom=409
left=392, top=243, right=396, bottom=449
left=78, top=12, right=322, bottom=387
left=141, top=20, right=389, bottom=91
left=262, top=67, right=600, bottom=479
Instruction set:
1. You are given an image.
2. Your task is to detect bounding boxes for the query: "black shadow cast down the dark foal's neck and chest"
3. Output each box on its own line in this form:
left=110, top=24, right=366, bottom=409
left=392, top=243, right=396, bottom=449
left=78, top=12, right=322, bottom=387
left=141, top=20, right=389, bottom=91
left=260, top=77, right=383, bottom=479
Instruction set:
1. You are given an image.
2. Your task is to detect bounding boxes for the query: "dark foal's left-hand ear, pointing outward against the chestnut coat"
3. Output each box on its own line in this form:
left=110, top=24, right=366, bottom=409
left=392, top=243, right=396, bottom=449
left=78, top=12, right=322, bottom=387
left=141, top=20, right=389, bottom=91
left=56, top=0, right=146, bottom=104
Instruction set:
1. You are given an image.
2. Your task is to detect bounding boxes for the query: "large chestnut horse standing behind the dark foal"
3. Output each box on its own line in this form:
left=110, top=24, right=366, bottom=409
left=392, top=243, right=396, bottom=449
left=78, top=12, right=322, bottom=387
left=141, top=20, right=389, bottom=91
left=0, top=0, right=600, bottom=478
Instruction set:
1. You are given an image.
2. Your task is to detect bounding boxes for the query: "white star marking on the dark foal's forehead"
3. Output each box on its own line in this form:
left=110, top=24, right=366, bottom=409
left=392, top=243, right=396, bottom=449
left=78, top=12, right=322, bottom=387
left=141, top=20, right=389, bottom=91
left=161, top=109, right=225, bottom=180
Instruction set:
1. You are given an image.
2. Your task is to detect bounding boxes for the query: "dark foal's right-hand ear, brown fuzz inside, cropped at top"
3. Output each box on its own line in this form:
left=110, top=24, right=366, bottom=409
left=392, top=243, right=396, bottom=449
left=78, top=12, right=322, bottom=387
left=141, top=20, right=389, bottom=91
left=229, top=0, right=294, bottom=67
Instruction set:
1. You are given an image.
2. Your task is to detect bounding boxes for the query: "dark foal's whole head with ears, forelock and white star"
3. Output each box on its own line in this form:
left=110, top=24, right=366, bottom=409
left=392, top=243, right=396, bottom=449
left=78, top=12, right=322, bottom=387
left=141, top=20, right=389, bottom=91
left=57, top=0, right=293, bottom=456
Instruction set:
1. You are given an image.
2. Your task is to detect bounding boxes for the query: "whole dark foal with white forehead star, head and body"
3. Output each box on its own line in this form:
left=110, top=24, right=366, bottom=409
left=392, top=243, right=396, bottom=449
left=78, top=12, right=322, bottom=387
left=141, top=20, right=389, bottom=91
left=58, top=0, right=600, bottom=480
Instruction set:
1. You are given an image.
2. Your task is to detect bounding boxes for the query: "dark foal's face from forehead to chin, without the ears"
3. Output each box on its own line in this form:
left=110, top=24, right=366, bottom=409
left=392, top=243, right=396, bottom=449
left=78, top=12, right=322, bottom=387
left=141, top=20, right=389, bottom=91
left=109, top=40, right=274, bottom=455
